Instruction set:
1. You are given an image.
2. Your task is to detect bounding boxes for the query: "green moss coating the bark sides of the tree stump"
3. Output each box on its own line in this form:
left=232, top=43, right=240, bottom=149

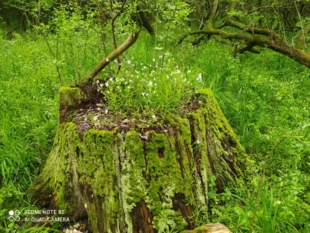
left=27, top=87, right=248, bottom=232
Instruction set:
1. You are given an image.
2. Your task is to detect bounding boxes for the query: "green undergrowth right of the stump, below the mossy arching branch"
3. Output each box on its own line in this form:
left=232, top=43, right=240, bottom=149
left=190, top=43, right=310, bottom=232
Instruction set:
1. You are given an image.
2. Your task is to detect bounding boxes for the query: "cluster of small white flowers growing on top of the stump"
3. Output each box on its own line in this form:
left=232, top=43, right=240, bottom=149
left=105, top=53, right=206, bottom=114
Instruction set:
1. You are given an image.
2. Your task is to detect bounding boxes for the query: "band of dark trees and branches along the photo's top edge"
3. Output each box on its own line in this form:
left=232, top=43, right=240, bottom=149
left=0, top=0, right=310, bottom=67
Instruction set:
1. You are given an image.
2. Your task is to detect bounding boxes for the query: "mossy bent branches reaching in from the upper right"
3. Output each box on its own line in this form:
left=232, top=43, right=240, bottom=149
left=177, top=0, right=310, bottom=68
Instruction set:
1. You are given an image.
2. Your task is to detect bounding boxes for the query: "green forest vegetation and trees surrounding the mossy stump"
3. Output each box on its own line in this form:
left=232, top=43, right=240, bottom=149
left=0, top=0, right=310, bottom=233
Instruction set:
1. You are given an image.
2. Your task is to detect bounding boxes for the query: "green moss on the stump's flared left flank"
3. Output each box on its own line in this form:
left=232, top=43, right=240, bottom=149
left=29, top=123, right=81, bottom=215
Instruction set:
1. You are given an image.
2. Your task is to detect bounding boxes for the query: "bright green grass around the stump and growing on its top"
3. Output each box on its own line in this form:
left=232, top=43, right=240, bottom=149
left=0, top=13, right=310, bottom=233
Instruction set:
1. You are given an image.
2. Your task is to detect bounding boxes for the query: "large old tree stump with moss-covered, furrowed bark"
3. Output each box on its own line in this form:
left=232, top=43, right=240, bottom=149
left=28, top=87, right=246, bottom=233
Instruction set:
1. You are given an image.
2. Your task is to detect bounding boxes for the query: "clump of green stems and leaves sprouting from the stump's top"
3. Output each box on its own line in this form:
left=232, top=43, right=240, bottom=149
left=102, top=44, right=199, bottom=118
